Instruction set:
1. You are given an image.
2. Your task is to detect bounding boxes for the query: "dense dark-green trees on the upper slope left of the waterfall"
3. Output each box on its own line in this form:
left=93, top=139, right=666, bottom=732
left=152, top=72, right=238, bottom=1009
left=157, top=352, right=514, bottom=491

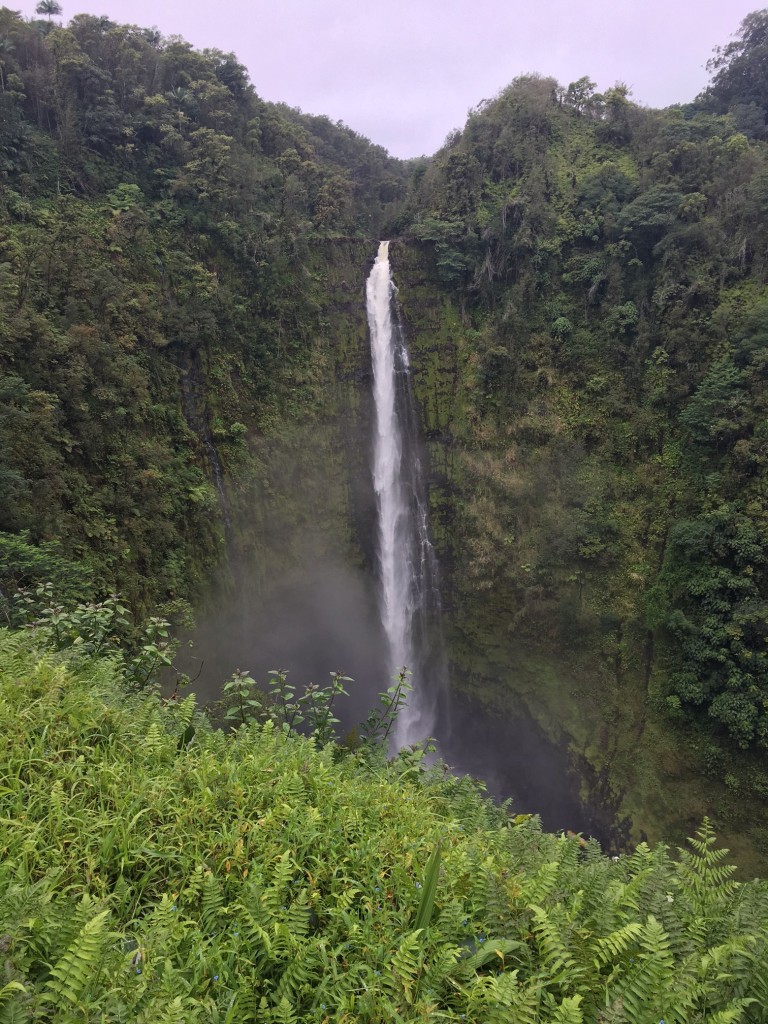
left=0, top=8, right=404, bottom=611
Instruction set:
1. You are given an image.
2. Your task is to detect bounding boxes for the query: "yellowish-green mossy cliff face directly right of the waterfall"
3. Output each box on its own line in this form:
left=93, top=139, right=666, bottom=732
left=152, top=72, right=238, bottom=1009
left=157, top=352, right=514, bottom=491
left=391, top=241, right=765, bottom=870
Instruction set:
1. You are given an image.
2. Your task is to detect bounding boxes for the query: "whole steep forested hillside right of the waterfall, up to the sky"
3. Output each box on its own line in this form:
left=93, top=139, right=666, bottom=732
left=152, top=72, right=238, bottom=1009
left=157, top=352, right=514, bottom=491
left=393, top=11, right=768, bottom=850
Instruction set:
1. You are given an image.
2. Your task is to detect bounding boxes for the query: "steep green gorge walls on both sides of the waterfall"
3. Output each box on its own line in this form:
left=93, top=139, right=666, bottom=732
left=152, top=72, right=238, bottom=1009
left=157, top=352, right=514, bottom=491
left=0, top=9, right=768, bottom=871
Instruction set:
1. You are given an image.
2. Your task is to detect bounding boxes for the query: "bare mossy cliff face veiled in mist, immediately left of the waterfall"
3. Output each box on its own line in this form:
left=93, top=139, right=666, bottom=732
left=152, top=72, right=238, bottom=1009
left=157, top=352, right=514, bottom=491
left=177, top=239, right=389, bottom=729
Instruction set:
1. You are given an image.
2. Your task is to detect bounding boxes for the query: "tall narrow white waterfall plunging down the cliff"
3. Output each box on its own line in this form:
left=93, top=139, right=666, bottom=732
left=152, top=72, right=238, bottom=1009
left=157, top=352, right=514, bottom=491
left=366, top=242, right=444, bottom=749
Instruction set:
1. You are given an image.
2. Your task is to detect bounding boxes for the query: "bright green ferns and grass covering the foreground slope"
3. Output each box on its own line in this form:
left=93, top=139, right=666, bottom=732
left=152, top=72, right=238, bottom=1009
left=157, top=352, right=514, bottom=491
left=0, top=631, right=768, bottom=1024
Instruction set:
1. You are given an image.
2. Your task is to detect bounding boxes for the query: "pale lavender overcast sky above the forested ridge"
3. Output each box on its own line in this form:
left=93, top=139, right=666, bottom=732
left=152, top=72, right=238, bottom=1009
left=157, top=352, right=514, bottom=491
left=12, top=0, right=761, bottom=157
